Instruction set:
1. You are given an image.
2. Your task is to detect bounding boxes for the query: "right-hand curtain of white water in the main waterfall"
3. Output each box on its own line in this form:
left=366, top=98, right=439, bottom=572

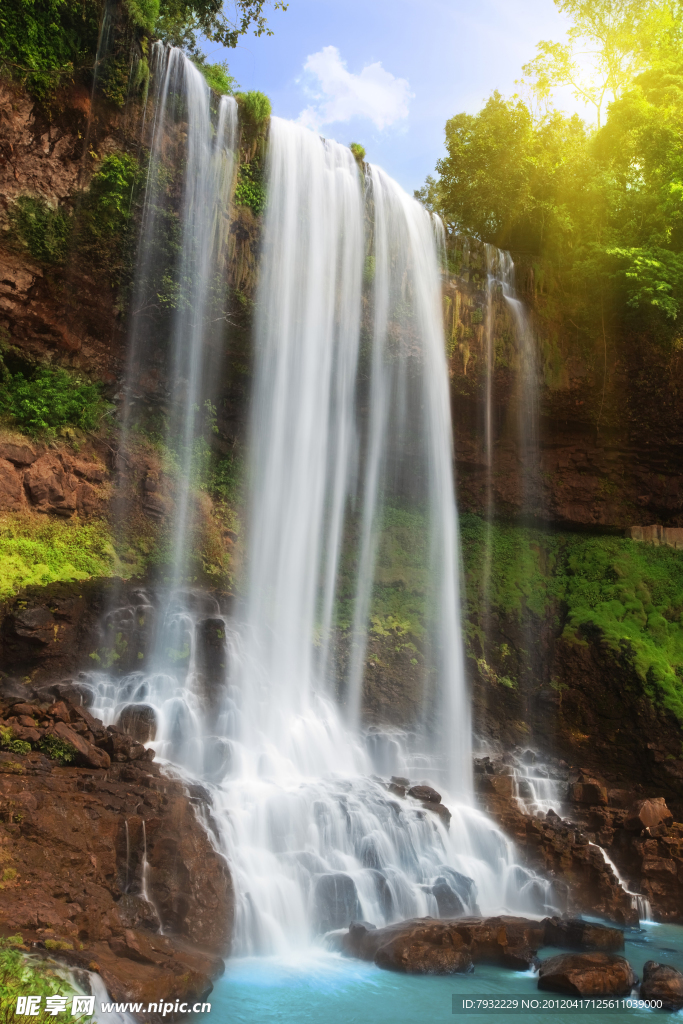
left=347, top=167, right=471, bottom=799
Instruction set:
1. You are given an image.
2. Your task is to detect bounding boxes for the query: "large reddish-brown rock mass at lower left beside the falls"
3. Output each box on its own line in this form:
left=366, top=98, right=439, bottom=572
left=0, top=684, right=233, bottom=1001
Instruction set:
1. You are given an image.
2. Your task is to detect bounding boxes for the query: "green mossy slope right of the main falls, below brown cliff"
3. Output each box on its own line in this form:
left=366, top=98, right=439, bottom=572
left=461, top=514, right=683, bottom=722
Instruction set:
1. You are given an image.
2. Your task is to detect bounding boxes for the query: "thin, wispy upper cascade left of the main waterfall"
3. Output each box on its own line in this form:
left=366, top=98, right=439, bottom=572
left=116, top=43, right=238, bottom=586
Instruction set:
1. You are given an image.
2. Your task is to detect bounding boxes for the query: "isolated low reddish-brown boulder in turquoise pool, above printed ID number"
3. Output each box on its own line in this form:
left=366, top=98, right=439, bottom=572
left=539, top=952, right=638, bottom=997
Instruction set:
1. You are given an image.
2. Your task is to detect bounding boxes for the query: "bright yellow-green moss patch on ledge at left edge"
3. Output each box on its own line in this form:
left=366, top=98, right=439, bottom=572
left=0, top=513, right=116, bottom=599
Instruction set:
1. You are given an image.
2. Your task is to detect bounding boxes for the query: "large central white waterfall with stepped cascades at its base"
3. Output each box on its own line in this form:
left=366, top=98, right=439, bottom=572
left=90, top=99, right=551, bottom=954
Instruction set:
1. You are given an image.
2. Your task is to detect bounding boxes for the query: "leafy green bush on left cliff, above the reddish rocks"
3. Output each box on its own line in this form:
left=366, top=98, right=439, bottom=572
left=0, top=358, right=105, bottom=437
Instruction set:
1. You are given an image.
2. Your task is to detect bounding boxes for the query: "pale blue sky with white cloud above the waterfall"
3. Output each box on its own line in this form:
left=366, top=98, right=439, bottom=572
left=208, top=0, right=573, bottom=193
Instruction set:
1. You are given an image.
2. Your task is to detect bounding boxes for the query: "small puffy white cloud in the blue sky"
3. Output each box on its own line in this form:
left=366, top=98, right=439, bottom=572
left=299, top=46, right=414, bottom=130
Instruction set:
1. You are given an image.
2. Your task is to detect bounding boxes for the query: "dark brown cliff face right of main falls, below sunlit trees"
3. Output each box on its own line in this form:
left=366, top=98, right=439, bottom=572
left=444, top=241, right=683, bottom=530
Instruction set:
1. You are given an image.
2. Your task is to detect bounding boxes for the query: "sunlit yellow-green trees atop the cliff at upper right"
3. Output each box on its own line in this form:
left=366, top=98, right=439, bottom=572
left=418, top=0, right=683, bottom=364
